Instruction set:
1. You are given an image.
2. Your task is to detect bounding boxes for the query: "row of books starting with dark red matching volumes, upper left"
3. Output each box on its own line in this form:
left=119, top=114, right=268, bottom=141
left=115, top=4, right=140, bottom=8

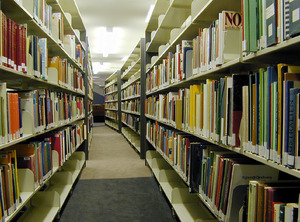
left=0, top=11, right=84, bottom=79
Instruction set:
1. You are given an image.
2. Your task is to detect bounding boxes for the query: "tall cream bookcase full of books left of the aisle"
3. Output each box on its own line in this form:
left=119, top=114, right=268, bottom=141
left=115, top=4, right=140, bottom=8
left=0, top=0, right=93, bottom=221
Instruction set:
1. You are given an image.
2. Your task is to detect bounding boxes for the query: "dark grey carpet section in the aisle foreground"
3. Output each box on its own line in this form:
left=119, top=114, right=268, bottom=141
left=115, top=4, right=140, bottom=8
left=60, top=177, right=176, bottom=222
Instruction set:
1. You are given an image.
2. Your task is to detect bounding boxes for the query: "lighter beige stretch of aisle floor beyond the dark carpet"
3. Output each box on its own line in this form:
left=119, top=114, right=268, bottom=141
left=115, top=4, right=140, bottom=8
left=81, top=123, right=151, bottom=179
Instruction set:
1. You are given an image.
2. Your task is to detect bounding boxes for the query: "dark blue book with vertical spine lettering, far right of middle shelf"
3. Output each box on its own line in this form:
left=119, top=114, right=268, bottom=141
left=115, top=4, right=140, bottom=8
left=287, top=88, right=300, bottom=168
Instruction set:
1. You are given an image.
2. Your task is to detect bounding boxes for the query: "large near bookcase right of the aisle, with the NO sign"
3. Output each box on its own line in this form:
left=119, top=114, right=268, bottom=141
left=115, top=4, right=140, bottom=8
left=141, top=0, right=300, bottom=221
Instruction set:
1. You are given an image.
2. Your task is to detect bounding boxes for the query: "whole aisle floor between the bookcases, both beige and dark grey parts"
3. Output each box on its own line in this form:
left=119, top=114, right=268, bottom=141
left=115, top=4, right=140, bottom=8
left=59, top=126, right=176, bottom=222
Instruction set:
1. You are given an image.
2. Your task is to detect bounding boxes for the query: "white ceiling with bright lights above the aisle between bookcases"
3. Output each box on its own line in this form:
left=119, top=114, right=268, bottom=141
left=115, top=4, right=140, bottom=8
left=76, top=0, right=155, bottom=85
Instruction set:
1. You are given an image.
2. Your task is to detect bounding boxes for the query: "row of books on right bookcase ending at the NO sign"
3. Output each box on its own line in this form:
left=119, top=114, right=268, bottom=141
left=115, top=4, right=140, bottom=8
left=146, top=11, right=242, bottom=91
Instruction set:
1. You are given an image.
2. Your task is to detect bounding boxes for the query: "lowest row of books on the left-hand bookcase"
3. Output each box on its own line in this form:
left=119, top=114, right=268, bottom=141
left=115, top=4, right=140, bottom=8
left=0, top=121, right=84, bottom=221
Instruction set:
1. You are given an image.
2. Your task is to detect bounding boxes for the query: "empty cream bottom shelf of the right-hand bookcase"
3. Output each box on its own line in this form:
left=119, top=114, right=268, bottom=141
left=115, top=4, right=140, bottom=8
left=146, top=150, right=218, bottom=222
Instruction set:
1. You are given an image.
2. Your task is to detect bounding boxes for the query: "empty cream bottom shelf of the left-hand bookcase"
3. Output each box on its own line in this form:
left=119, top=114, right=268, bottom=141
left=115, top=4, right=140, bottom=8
left=18, top=152, right=85, bottom=222
